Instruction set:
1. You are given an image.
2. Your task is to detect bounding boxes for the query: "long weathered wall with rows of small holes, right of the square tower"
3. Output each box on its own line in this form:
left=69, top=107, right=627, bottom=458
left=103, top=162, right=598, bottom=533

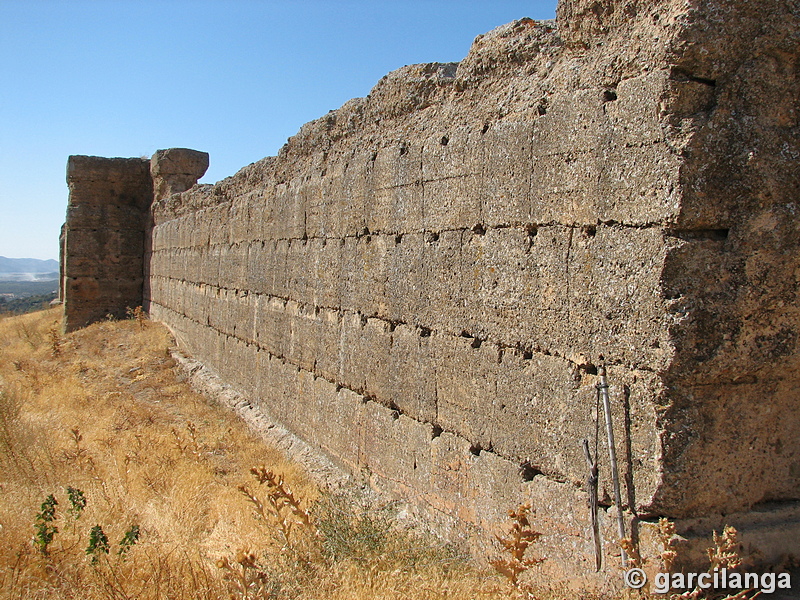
left=64, top=0, right=800, bottom=583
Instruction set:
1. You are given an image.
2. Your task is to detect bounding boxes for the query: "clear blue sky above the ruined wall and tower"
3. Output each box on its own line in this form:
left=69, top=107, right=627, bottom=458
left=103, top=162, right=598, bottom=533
left=0, top=0, right=556, bottom=259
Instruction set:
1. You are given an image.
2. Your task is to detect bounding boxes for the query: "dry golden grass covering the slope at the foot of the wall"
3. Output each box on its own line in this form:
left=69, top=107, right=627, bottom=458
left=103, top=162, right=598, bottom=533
left=0, top=309, right=511, bottom=600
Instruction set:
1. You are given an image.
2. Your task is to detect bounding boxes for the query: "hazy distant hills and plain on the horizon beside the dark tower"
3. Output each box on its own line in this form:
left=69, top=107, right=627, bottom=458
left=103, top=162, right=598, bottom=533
left=0, top=256, right=58, bottom=314
